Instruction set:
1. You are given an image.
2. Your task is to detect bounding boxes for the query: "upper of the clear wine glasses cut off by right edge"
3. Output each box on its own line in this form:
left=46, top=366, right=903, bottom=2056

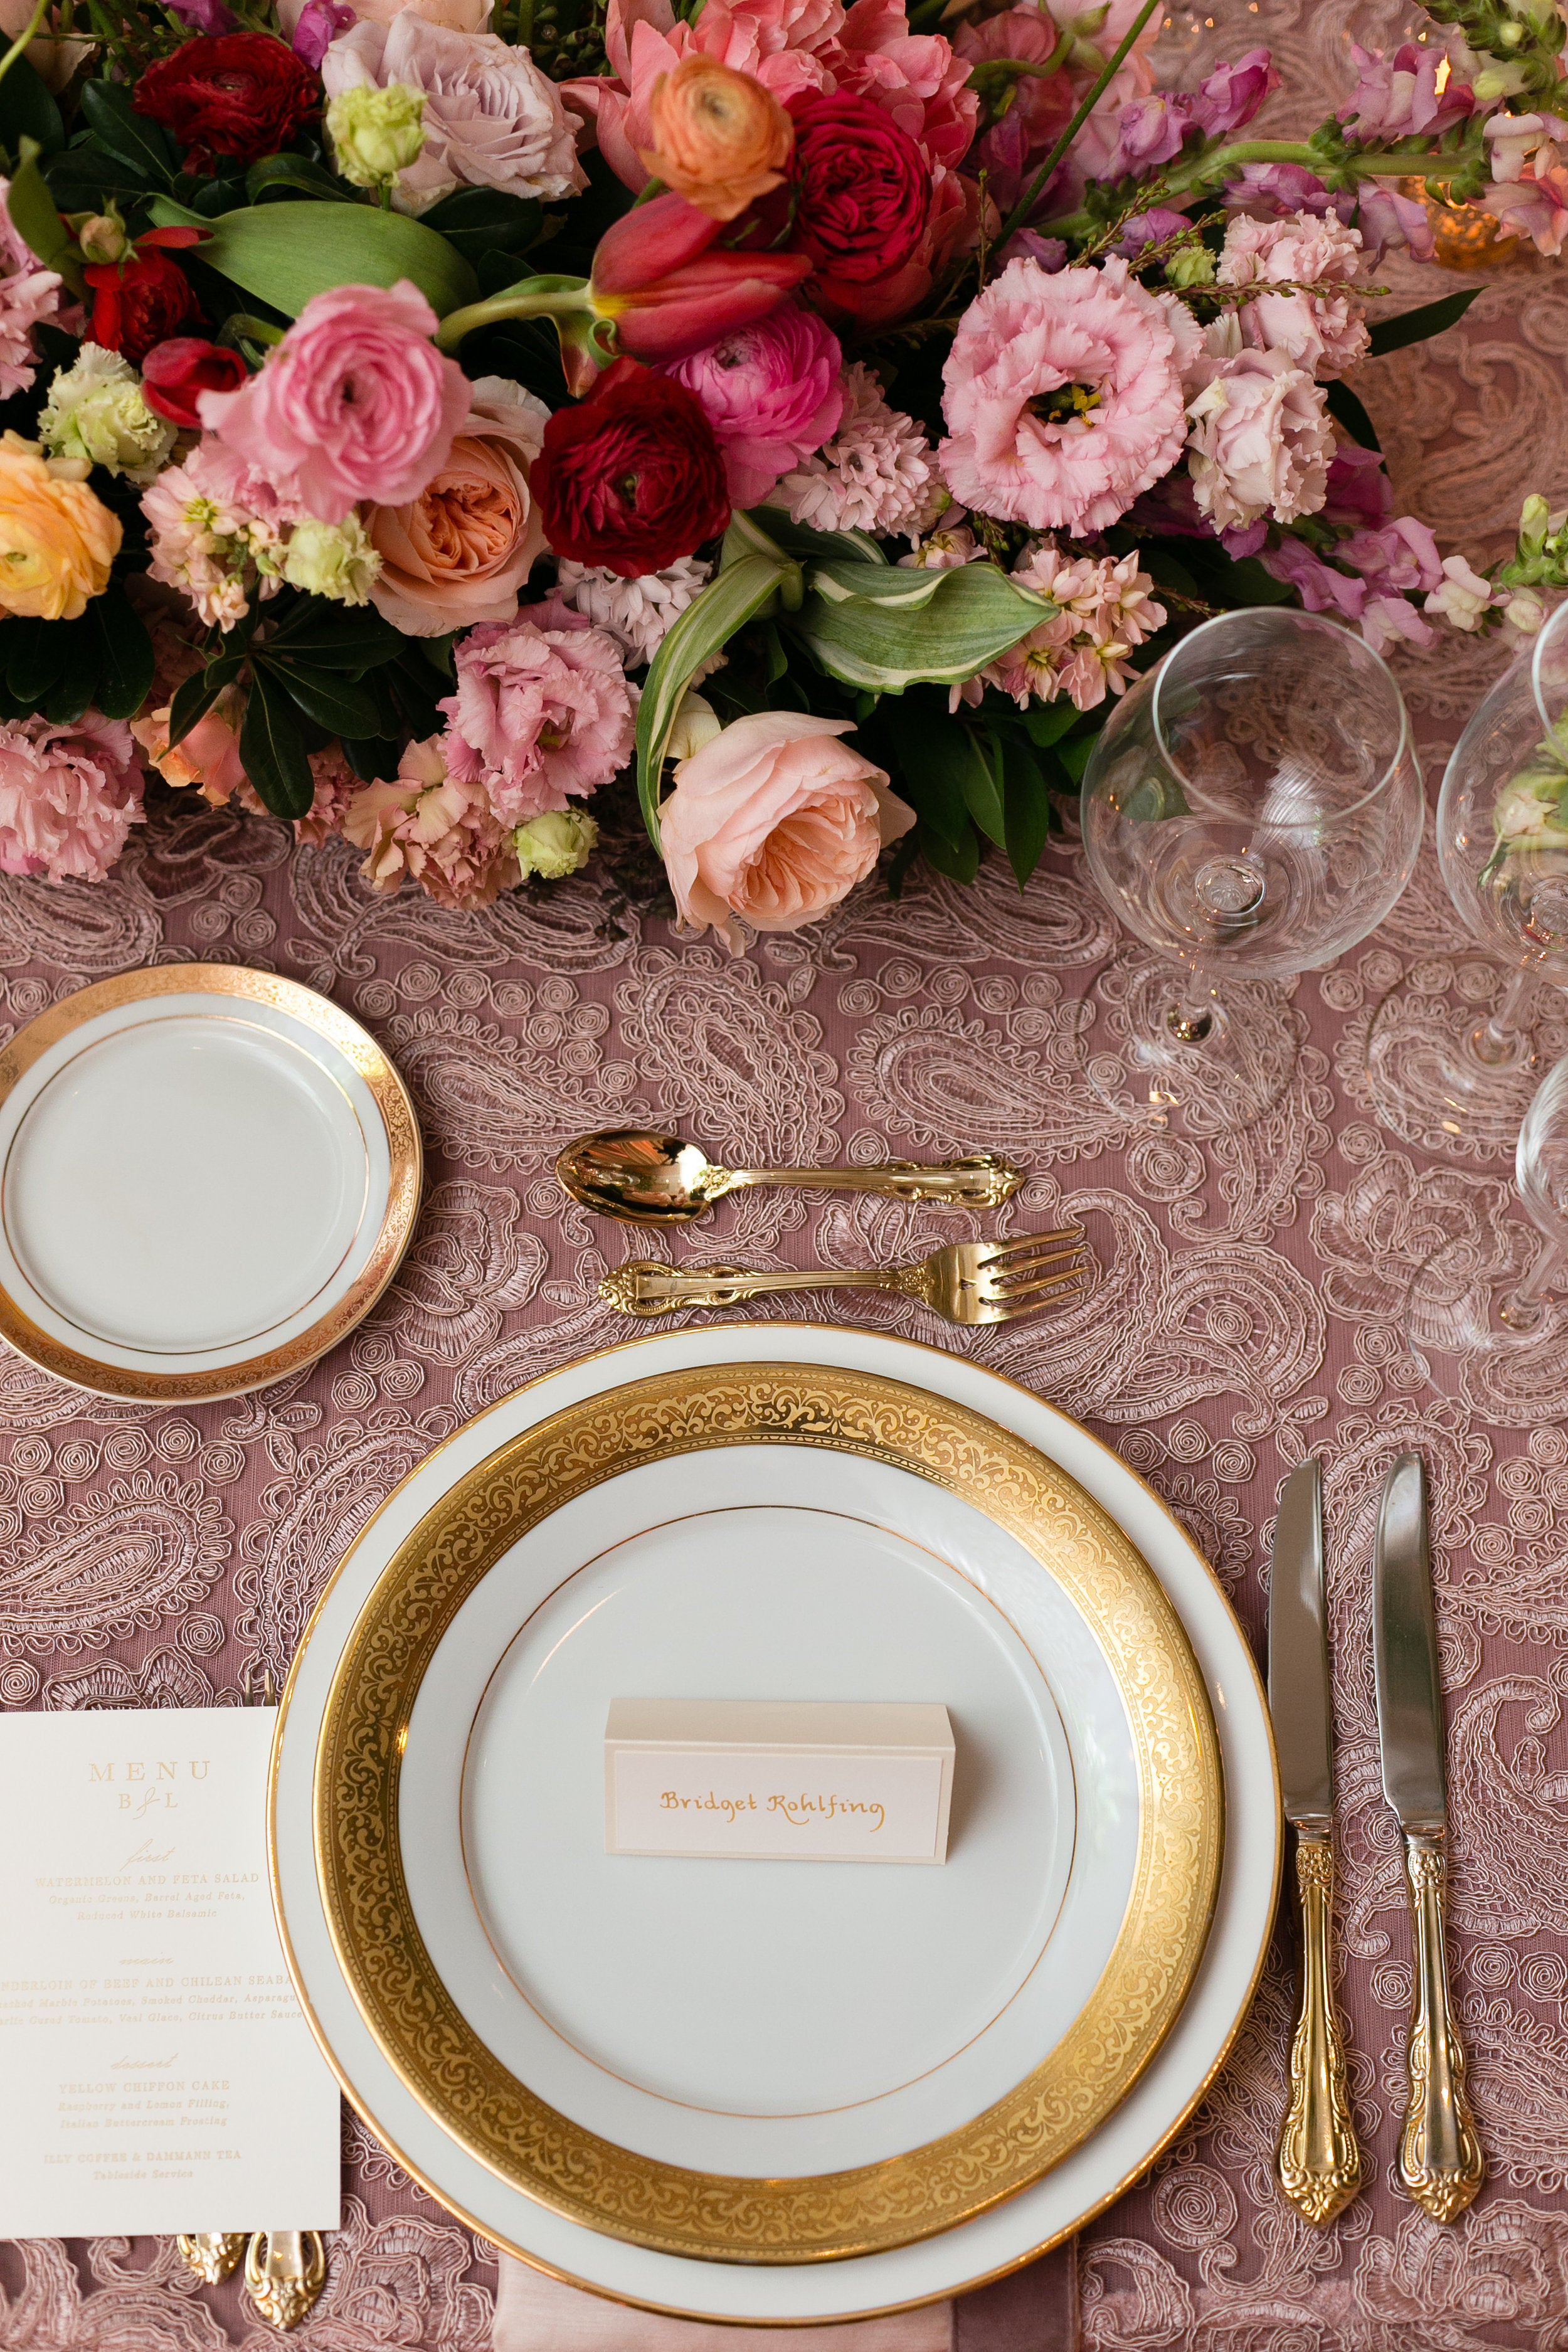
left=1366, top=605, right=1568, bottom=1160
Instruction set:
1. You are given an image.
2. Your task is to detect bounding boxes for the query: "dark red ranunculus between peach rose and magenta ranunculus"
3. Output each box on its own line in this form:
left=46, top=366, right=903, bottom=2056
left=529, top=360, right=729, bottom=581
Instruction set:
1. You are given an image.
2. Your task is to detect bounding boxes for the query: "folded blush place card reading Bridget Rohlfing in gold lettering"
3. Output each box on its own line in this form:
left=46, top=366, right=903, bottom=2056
left=604, top=1698, right=952, bottom=1863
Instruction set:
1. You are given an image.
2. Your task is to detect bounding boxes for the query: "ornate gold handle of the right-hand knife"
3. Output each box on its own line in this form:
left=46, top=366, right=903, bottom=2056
left=1399, top=1830, right=1486, bottom=2220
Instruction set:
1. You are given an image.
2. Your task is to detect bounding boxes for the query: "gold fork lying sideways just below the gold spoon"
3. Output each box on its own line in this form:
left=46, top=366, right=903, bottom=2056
left=600, top=1226, right=1093, bottom=1324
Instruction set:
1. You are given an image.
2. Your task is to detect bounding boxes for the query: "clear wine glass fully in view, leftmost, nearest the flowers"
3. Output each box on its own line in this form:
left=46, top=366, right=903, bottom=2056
left=1079, top=605, right=1422, bottom=1136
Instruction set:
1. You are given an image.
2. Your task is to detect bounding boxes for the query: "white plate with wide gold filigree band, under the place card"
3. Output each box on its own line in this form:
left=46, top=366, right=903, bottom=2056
left=297, top=1357, right=1225, bottom=2265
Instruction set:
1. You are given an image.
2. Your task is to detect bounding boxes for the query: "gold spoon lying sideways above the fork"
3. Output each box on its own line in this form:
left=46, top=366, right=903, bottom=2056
left=555, top=1126, right=1022, bottom=1226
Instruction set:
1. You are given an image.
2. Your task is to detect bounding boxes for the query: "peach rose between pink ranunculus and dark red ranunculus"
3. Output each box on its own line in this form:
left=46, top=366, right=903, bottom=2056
left=364, top=376, right=550, bottom=637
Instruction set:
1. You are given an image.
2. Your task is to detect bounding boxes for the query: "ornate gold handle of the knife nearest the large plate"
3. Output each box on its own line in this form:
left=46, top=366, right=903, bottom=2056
left=1279, top=1830, right=1361, bottom=2227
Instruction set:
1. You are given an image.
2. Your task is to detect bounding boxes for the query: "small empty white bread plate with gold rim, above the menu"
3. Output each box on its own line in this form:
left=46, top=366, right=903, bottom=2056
left=0, top=965, right=421, bottom=1404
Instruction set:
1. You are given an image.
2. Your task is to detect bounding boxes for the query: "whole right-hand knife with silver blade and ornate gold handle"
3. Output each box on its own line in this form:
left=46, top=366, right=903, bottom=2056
left=1373, top=1454, right=1486, bottom=2220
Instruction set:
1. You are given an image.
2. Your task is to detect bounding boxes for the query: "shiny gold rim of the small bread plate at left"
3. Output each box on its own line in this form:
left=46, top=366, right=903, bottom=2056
left=0, top=965, right=423, bottom=1404
